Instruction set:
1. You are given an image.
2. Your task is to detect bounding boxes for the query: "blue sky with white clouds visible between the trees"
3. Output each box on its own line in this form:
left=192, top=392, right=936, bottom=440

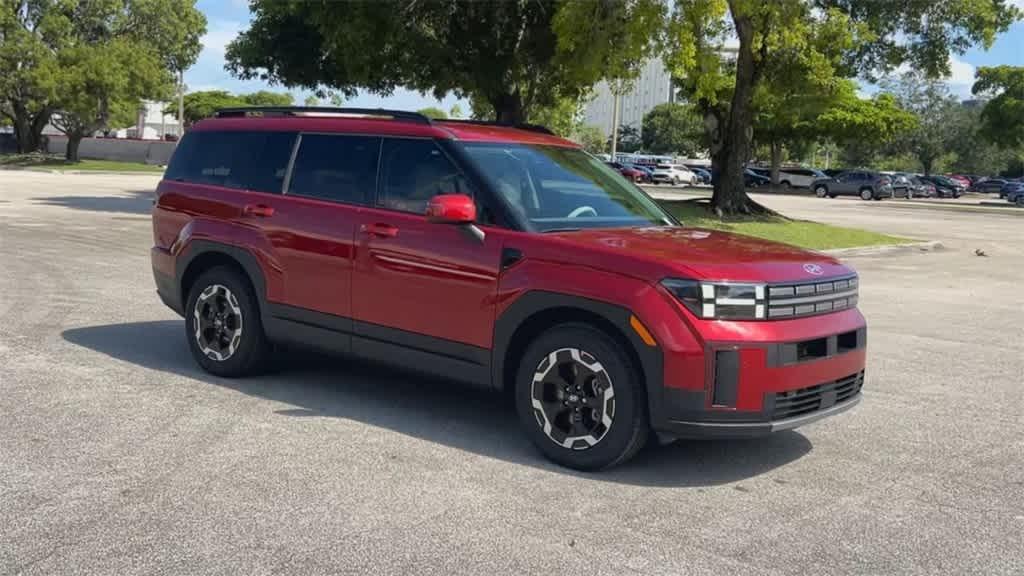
left=185, top=0, right=1024, bottom=106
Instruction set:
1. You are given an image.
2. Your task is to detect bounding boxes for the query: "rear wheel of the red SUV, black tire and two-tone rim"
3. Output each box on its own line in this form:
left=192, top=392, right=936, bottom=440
left=185, top=266, right=271, bottom=378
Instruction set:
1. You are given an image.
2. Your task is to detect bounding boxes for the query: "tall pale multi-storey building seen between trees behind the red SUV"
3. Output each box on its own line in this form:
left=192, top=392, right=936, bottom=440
left=584, top=58, right=676, bottom=135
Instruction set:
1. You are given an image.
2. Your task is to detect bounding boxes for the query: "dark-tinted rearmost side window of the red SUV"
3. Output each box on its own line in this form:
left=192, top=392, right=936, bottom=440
left=164, top=131, right=295, bottom=194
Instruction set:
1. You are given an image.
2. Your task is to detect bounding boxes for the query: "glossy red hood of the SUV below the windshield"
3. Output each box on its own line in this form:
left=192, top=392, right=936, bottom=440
left=554, top=227, right=853, bottom=283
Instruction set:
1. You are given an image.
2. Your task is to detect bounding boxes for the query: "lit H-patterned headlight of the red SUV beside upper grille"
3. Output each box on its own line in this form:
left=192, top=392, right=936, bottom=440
left=662, top=278, right=767, bottom=320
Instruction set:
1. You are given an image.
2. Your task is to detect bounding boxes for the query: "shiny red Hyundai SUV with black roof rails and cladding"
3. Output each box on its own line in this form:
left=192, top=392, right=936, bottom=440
left=153, top=109, right=865, bottom=469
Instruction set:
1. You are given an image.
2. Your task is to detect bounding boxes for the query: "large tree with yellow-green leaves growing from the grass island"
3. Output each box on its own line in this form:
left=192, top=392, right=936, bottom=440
left=665, top=0, right=1019, bottom=212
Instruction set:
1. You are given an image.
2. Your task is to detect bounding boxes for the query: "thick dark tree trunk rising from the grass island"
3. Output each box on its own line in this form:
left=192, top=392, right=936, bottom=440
left=712, top=8, right=757, bottom=214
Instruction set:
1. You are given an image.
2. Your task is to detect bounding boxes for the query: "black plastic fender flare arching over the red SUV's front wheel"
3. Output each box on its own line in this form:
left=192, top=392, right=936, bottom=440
left=490, top=290, right=665, bottom=425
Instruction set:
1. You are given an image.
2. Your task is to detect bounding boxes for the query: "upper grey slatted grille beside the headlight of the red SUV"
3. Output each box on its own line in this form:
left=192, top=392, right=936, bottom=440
left=768, top=276, right=857, bottom=319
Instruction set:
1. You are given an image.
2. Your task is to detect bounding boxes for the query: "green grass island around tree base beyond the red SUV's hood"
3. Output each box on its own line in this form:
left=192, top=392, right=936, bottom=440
left=662, top=201, right=911, bottom=250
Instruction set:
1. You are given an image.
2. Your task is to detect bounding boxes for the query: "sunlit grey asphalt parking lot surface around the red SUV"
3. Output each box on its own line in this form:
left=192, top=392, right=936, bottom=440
left=0, top=171, right=1024, bottom=576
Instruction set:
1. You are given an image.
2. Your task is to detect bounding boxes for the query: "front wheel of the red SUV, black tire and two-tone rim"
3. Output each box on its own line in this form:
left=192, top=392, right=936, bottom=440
left=515, top=324, right=649, bottom=470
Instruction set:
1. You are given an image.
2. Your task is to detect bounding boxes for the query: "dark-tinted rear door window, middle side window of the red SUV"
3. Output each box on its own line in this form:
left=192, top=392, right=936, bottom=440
left=288, top=134, right=381, bottom=204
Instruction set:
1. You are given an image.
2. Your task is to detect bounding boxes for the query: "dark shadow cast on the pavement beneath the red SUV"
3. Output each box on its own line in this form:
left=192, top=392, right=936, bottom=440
left=62, top=321, right=812, bottom=487
